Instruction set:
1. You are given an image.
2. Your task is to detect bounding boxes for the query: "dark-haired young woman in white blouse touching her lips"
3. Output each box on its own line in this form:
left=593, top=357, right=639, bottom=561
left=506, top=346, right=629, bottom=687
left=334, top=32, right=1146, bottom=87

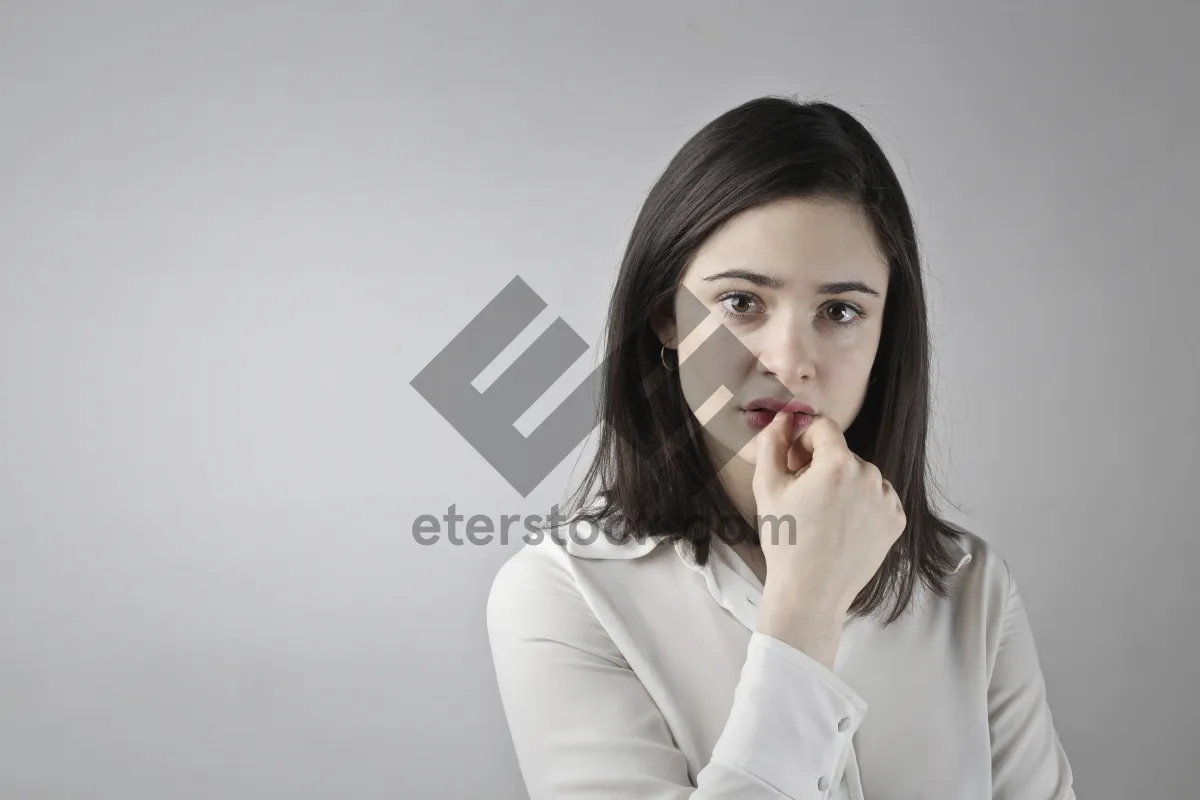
left=487, top=97, right=1075, bottom=800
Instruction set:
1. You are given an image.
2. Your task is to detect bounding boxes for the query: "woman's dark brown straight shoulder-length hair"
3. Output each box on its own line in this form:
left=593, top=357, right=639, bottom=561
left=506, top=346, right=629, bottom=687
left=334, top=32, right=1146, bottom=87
left=568, top=96, right=960, bottom=624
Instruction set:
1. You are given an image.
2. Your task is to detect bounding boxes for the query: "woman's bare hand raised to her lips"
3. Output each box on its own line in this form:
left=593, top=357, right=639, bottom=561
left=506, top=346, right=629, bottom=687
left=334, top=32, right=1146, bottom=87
left=752, top=413, right=908, bottom=667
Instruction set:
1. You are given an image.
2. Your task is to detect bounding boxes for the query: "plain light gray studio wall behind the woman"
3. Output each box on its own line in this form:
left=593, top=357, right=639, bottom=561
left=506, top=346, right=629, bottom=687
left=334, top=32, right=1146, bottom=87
left=0, top=0, right=1200, bottom=800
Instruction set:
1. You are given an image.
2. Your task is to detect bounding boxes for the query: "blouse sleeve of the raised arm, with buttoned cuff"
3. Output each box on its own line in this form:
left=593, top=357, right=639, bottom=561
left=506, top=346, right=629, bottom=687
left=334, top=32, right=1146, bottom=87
left=487, top=553, right=866, bottom=800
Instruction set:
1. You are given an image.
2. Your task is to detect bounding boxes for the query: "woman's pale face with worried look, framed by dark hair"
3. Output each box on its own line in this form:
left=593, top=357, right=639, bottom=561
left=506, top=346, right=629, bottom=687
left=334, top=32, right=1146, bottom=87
left=655, top=199, right=888, bottom=464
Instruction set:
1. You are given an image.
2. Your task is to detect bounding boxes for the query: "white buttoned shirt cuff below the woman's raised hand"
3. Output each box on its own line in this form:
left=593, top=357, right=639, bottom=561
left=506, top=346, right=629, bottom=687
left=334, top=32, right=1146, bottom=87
left=713, top=631, right=868, bottom=799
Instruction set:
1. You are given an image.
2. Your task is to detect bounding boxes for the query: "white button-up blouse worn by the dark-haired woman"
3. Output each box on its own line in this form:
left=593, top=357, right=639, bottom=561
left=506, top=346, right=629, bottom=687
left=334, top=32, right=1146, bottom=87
left=487, top=527, right=1075, bottom=800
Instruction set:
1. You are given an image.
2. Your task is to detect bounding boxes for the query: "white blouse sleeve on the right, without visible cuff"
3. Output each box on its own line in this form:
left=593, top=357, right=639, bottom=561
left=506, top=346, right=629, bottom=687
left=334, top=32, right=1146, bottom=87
left=988, top=564, right=1075, bottom=800
